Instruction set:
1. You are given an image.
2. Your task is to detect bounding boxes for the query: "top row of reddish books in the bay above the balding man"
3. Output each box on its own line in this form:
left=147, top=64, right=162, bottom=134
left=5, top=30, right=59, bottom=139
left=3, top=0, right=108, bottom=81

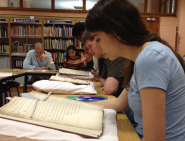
left=11, top=25, right=42, bottom=38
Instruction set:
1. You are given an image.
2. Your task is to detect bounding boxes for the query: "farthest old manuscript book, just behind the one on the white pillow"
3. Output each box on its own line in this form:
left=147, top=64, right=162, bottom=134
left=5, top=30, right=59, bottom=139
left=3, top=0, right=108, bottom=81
left=59, top=68, right=89, bottom=76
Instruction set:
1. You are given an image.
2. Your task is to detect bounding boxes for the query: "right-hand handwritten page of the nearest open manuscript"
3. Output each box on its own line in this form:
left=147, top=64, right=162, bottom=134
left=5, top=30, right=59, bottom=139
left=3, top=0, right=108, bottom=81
left=33, top=99, right=103, bottom=130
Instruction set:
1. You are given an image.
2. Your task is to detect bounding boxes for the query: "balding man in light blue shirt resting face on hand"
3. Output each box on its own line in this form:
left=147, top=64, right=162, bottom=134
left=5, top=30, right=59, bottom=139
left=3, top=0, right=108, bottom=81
left=23, top=42, right=55, bottom=83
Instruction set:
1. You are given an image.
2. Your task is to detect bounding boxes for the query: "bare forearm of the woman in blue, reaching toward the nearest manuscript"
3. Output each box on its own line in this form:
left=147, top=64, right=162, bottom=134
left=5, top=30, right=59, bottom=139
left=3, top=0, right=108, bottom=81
left=91, top=89, right=128, bottom=112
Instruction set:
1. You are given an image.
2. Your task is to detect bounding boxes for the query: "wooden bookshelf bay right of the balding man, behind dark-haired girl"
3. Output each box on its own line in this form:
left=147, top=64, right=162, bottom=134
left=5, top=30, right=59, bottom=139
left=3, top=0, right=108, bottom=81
left=43, top=20, right=75, bottom=69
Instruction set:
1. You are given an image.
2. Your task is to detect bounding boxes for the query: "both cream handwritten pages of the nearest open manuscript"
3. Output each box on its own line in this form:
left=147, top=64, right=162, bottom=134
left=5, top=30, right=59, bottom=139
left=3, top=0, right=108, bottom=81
left=0, top=97, right=103, bottom=131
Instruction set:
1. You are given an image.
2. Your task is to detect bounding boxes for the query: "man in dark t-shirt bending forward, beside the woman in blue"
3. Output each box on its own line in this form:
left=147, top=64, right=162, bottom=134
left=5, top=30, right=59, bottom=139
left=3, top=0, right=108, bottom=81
left=82, top=31, right=125, bottom=97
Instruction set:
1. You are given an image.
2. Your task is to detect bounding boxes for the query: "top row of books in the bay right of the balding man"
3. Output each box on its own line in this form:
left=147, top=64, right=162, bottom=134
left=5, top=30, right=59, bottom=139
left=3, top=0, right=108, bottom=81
left=44, top=25, right=72, bottom=37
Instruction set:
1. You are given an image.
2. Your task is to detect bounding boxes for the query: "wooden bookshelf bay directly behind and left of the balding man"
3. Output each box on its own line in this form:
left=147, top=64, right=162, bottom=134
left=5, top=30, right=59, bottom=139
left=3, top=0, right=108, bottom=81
left=10, top=18, right=43, bottom=69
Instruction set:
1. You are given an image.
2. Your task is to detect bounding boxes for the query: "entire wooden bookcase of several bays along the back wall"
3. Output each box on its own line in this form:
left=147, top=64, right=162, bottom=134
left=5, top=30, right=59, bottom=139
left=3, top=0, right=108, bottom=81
left=0, top=17, right=83, bottom=69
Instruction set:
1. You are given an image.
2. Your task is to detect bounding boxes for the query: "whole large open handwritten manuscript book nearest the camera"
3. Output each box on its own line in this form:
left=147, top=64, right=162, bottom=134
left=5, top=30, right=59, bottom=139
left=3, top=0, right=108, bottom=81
left=0, top=91, right=103, bottom=138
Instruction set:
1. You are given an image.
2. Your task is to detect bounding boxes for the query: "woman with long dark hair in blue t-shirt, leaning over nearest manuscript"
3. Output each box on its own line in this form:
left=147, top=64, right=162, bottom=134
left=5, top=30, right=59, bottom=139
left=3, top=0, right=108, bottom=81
left=85, top=0, right=185, bottom=141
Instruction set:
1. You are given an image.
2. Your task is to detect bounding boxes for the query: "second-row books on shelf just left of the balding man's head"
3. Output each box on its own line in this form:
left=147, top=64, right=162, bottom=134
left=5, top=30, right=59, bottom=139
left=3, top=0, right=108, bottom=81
left=12, top=43, right=34, bottom=53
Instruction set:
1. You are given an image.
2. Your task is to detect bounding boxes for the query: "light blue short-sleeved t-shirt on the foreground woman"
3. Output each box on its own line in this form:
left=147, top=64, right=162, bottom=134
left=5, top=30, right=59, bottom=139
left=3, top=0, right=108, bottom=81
left=128, top=41, right=185, bottom=141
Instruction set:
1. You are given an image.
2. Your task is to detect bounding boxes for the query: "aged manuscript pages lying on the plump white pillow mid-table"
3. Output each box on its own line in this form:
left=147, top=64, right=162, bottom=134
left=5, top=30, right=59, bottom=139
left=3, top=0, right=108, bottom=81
left=50, top=76, right=90, bottom=85
